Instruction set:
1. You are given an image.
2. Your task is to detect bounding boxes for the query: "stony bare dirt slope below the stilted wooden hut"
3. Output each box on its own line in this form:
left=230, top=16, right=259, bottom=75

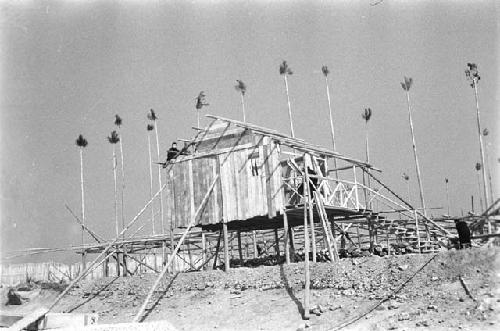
left=2, top=247, right=500, bottom=330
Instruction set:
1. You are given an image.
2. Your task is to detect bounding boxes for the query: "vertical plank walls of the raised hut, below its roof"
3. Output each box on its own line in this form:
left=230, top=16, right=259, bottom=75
left=165, top=130, right=284, bottom=228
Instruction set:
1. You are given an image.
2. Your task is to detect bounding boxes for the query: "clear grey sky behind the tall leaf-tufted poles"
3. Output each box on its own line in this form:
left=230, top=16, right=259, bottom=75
left=0, top=0, right=500, bottom=260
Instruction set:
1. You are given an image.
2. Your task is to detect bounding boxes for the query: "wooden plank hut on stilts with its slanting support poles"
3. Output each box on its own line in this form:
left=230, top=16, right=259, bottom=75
left=44, top=115, right=449, bottom=322
